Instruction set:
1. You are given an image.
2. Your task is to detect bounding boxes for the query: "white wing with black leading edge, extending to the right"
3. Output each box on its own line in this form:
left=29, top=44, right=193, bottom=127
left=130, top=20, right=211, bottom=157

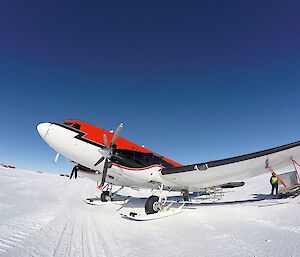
left=161, top=141, right=300, bottom=191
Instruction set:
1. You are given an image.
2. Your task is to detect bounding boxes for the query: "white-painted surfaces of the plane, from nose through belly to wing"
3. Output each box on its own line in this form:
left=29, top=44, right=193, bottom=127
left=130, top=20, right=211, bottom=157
left=37, top=123, right=300, bottom=191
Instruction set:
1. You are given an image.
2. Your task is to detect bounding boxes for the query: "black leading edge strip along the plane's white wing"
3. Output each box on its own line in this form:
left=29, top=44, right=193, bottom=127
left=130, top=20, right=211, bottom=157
left=161, top=141, right=300, bottom=175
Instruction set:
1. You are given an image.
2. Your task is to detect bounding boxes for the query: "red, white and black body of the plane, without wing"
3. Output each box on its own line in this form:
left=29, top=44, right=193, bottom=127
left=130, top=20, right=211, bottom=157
left=37, top=120, right=181, bottom=188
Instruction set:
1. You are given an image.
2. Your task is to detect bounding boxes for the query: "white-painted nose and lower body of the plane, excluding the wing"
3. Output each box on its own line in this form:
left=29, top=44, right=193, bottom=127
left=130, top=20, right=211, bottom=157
left=38, top=123, right=167, bottom=188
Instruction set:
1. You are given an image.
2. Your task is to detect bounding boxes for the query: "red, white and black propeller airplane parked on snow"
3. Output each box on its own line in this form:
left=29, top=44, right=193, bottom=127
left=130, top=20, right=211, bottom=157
left=37, top=120, right=300, bottom=215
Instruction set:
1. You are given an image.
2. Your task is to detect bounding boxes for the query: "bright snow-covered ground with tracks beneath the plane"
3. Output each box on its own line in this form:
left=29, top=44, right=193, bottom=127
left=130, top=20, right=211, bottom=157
left=0, top=169, right=300, bottom=257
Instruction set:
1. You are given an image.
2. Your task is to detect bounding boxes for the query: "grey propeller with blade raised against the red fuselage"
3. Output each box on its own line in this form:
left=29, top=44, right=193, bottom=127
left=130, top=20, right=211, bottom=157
left=94, top=123, right=123, bottom=186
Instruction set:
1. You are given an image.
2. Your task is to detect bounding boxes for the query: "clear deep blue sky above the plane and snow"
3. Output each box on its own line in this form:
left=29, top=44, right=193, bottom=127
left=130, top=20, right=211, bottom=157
left=0, top=1, right=300, bottom=171
